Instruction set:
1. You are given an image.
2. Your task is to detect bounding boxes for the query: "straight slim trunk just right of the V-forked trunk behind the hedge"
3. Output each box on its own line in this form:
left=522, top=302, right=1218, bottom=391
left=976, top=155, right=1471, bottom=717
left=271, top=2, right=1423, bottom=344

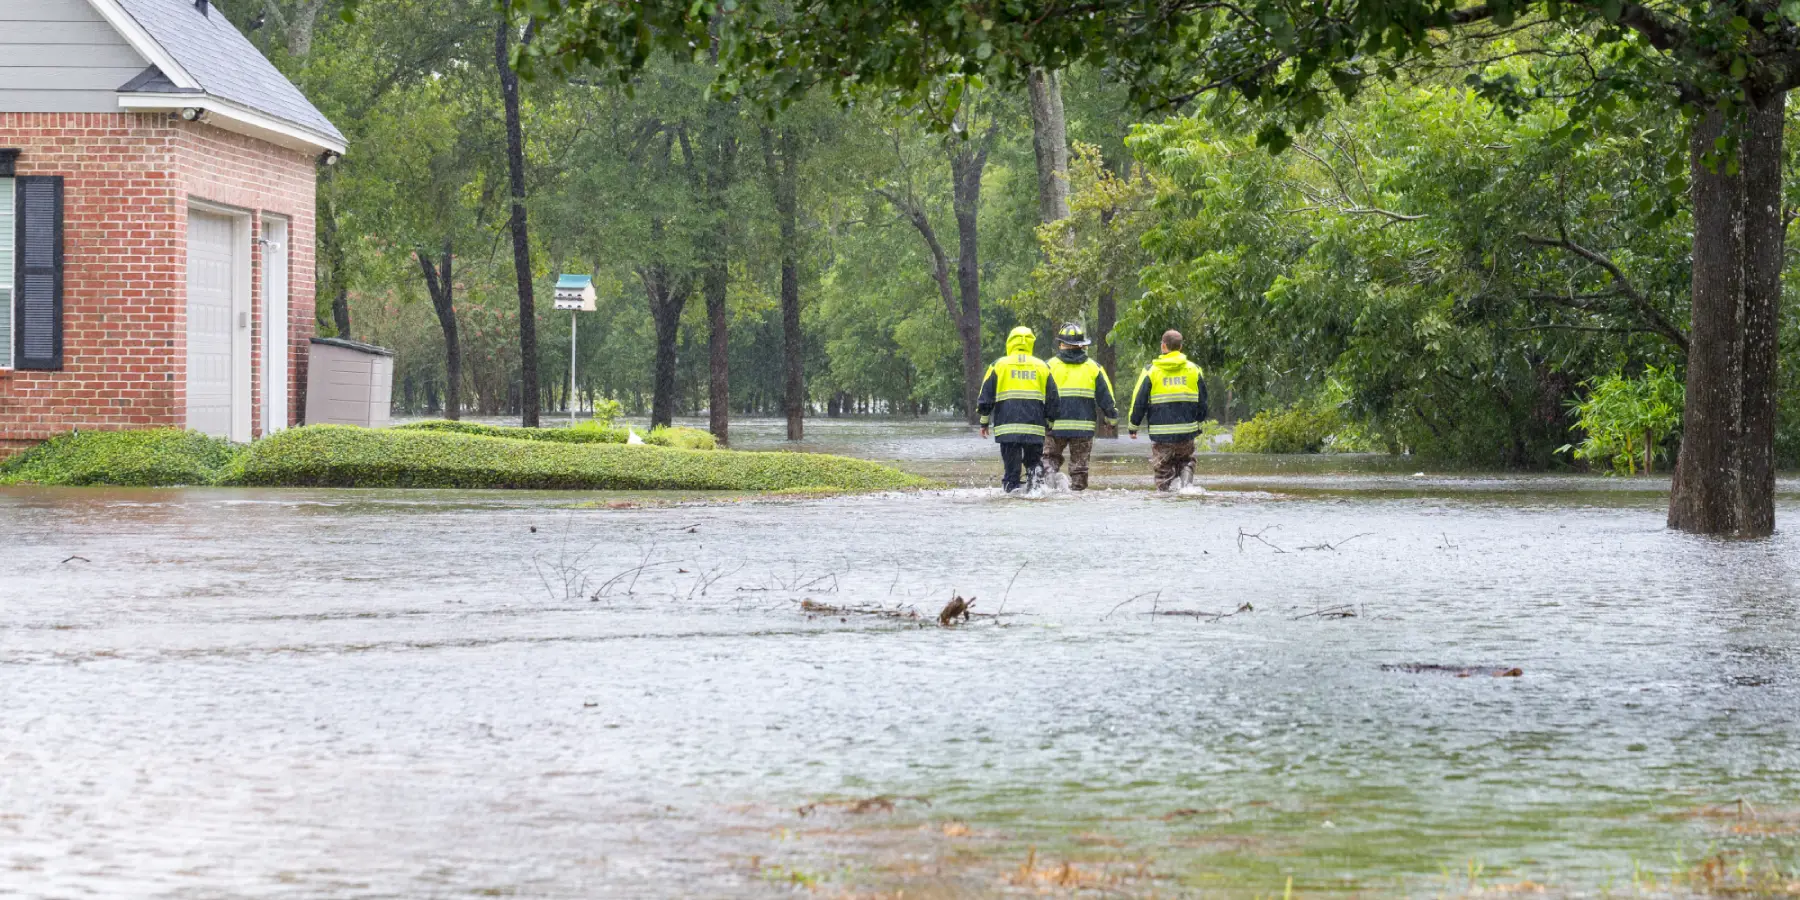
left=700, top=98, right=738, bottom=446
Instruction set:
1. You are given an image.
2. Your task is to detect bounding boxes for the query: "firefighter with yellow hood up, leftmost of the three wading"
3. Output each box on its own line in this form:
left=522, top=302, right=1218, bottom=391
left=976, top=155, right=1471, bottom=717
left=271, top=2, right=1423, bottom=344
left=976, top=326, right=1057, bottom=493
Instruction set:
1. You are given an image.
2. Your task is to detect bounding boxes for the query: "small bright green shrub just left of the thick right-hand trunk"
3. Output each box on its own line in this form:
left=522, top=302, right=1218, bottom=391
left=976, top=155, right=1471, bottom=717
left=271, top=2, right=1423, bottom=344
left=1562, top=367, right=1685, bottom=475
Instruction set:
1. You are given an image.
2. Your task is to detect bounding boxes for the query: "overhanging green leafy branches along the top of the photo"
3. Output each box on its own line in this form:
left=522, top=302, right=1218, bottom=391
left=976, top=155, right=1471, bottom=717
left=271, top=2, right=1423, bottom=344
left=514, top=0, right=1800, bottom=160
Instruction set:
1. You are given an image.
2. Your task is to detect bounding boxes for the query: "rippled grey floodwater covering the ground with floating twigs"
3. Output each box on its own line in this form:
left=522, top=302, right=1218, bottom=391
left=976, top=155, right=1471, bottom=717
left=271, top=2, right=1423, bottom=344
left=0, top=421, right=1800, bottom=898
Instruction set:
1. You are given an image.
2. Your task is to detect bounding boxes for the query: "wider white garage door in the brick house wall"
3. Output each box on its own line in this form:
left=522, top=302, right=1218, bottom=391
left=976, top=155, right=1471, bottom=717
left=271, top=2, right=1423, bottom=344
left=187, top=211, right=238, bottom=437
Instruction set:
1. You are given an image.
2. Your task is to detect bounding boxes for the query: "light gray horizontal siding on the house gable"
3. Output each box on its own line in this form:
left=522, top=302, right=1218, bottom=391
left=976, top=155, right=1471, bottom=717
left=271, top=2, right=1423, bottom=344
left=0, top=0, right=149, bottom=112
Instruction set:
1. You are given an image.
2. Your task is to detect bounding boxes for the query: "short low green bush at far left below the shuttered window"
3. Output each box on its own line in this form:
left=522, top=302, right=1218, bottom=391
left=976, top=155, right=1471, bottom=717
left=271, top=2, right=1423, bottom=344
left=0, top=428, right=243, bottom=488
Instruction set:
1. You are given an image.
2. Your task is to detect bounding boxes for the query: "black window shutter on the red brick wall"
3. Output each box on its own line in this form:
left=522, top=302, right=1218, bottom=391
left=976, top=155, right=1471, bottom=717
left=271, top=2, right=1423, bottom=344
left=13, top=175, right=63, bottom=369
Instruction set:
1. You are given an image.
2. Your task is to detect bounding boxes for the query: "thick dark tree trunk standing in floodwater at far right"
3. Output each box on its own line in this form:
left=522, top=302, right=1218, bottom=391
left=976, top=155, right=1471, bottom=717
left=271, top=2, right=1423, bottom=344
left=1669, top=94, right=1786, bottom=538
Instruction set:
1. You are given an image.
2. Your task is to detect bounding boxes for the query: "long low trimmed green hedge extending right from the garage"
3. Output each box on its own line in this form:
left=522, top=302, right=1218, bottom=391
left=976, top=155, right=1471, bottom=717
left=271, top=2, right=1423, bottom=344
left=232, top=425, right=925, bottom=491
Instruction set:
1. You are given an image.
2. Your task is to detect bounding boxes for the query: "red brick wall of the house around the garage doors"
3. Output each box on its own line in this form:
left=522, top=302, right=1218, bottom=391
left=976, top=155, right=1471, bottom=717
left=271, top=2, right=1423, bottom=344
left=0, top=113, right=315, bottom=455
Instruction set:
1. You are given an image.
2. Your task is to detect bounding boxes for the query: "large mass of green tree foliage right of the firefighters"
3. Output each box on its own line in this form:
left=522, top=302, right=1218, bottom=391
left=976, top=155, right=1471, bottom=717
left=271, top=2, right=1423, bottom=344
left=1120, top=77, right=1692, bottom=466
